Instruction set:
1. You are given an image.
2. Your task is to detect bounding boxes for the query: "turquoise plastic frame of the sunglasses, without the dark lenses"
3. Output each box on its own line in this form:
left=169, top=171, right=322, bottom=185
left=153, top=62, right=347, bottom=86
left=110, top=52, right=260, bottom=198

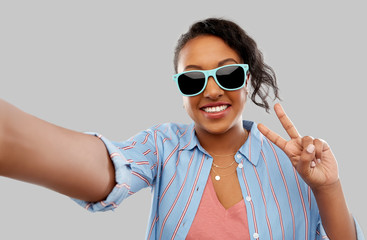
left=173, top=64, right=249, bottom=97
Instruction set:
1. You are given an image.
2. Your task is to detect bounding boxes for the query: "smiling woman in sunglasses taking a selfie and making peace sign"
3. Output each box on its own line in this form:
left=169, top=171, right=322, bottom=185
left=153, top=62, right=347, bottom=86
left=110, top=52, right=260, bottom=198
left=0, top=19, right=362, bottom=239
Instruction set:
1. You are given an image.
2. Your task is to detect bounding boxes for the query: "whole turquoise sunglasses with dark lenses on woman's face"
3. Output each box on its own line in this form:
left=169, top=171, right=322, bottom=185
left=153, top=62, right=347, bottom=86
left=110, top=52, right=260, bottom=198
left=173, top=64, right=248, bottom=97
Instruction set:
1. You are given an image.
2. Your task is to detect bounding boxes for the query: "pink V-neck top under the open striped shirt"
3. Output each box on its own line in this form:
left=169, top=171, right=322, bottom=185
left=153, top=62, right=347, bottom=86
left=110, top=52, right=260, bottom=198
left=186, top=176, right=250, bottom=240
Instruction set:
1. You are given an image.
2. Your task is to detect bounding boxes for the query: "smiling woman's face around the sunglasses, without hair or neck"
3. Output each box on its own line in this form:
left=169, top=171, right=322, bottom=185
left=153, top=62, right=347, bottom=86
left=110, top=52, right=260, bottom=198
left=177, top=35, right=247, bottom=137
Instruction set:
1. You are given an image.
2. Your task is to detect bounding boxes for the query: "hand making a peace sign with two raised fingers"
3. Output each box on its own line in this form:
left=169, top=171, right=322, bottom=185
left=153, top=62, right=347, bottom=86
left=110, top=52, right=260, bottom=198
left=258, top=103, right=339, bottom=189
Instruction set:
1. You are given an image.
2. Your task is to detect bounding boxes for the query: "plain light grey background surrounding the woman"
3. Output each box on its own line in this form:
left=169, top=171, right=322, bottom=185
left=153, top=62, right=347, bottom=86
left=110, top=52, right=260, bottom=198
left=0, top=0, right=367, bottom=239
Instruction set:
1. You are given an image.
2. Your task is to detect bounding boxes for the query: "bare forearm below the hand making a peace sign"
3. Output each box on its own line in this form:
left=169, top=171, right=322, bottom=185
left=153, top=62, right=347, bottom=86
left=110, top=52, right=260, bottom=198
left=313, top=180, right=356, bottom=240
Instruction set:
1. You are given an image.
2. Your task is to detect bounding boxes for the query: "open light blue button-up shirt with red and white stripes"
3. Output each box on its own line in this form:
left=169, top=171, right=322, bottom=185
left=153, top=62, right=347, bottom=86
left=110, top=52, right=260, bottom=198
left=75, top=121, right=363, bottom=240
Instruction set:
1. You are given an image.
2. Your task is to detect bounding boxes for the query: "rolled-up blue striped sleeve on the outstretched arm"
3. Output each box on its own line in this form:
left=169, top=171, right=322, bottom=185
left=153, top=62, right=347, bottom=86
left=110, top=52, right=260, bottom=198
left=73, top=130, right=158, bottom=212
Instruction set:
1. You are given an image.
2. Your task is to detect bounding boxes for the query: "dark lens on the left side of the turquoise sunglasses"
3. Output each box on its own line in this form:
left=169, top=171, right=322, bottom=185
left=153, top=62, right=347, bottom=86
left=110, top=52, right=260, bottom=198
left=177, top=72, right=205, bottom=95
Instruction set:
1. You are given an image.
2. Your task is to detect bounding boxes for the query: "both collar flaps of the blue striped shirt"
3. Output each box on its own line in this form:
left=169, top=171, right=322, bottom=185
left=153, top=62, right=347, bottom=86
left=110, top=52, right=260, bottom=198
left=179, top=120, right=263, bottom=166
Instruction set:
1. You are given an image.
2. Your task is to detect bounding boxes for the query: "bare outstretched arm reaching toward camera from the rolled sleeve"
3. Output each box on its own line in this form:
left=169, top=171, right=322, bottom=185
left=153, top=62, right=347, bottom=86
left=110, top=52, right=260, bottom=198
left=0, top=100, right=114, bottom=201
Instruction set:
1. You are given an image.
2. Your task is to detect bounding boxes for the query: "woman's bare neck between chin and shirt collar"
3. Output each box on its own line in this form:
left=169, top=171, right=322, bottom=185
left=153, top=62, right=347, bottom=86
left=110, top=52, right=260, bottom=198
left=195, top=122, right=248, bottom=155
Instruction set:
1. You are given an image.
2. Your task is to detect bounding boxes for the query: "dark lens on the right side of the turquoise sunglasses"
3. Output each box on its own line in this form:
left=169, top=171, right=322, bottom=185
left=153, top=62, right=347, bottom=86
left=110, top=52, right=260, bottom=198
left=216, top=66, right=245, bottom=89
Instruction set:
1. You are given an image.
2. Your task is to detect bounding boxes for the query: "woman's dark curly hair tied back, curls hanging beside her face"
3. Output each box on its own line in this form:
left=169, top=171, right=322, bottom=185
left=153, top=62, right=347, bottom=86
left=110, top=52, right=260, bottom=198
left=173, top=18, right=280, bottom=112
